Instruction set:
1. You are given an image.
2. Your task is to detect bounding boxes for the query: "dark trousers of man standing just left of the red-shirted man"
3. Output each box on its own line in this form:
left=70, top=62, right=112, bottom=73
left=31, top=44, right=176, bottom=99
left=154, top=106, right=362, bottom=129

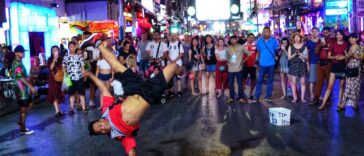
left=229, top=72, right=244, bottom=99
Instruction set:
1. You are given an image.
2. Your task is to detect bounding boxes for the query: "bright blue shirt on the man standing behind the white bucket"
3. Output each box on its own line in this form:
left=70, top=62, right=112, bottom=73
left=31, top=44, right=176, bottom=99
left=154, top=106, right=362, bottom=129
left=257, top=37, right=278, bottom=66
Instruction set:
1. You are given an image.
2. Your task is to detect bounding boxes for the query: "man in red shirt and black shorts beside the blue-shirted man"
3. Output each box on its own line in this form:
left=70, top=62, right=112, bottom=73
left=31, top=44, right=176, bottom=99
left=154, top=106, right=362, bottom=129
left=243, top=34, right=257, bottom=99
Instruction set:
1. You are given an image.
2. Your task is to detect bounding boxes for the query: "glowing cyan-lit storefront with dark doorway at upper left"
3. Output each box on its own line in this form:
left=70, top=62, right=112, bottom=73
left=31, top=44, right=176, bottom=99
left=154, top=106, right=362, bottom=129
left=10, top=2, right=59, bottom=72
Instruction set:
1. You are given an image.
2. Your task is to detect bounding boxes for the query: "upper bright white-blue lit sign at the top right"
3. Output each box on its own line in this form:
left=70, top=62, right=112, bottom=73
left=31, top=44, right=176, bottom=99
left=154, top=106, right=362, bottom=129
left=325, top=0, right=348, bottom=16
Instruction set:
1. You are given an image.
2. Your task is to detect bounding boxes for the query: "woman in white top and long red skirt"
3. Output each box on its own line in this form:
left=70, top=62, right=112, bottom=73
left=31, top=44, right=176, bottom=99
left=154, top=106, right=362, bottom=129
left=215, top=38, right=228, bottom=97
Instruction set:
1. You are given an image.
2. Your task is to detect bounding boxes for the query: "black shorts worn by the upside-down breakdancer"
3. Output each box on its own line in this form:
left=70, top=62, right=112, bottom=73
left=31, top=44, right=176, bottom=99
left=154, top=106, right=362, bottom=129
left=114, top=69, right=168, bottom=104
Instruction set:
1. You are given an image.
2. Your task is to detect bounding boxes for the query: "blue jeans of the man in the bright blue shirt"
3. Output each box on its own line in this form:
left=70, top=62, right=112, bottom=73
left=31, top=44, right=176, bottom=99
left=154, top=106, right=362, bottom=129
left=255, top=65, right=275, bottom=99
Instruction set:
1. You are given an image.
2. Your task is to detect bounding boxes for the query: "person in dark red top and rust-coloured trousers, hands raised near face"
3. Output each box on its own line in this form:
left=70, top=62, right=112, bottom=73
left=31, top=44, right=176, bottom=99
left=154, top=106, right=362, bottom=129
left=310, top=27, right=333, bottom=106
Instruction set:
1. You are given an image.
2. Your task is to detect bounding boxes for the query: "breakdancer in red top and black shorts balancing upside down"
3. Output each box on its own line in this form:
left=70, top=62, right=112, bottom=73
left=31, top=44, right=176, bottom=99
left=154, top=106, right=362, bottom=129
left=84, top=39, right=177, bottom=156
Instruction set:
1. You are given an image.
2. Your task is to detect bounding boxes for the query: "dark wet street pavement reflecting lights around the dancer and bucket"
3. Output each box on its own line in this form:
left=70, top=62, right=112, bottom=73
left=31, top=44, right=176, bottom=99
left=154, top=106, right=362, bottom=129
left=0, top=74, right=364, bottom=156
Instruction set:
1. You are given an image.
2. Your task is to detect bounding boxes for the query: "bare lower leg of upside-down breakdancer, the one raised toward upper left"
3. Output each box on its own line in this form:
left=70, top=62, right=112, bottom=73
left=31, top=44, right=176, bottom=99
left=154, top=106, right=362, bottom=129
left=96, top=43, right=127, bottom=73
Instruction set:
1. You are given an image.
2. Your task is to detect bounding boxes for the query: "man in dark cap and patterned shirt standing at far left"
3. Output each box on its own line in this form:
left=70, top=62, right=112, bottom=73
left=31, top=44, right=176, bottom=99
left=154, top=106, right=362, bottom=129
left=11, top=45, right=36, bottom=135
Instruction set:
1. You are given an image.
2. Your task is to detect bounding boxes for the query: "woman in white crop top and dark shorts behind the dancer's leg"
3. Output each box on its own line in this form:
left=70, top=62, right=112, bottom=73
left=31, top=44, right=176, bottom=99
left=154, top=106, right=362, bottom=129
left=96, top=53, right=114, bottom=110
